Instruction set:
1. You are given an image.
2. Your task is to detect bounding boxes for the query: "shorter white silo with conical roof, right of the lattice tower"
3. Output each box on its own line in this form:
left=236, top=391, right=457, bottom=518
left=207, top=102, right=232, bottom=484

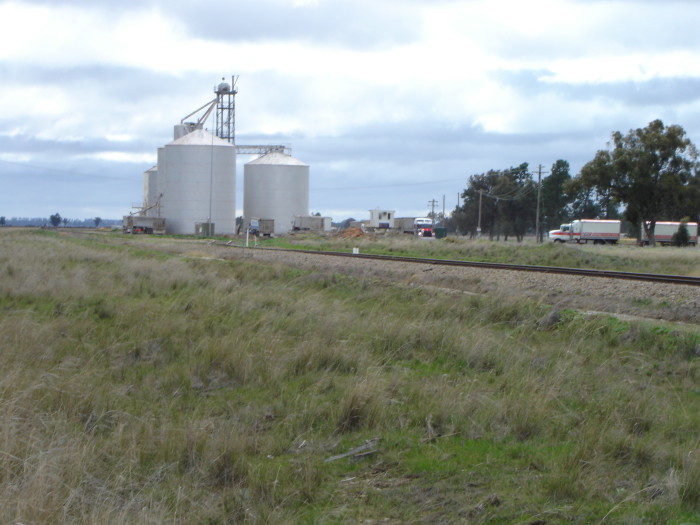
left=243, top=151, right=309, bottom=234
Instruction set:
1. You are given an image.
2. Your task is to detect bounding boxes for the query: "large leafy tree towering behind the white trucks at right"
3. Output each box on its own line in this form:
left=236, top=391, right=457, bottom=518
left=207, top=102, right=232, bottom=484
left=579, top=120, right=699, bottom=243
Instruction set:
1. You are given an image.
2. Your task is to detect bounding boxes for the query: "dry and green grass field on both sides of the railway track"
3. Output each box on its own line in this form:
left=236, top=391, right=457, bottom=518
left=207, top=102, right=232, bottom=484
left=0, top=229, right=700, bottom=524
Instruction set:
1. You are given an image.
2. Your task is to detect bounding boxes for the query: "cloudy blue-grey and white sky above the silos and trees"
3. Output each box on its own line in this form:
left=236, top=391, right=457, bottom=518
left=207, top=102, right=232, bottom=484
left=0, top=0, right=700, bottom=221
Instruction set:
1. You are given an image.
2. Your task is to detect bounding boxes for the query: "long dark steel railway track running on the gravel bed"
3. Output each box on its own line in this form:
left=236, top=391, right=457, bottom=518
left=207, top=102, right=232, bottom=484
left=217, top=243, right=700, bottom=286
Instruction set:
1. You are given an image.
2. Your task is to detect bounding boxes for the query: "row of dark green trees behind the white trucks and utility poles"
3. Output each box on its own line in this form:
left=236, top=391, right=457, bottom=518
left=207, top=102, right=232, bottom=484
left=452, top=120, right=700, bottom=241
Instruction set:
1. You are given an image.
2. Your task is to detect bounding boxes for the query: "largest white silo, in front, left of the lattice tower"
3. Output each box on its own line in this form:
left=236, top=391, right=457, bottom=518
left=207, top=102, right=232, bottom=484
left=157, top=129, right=236, bottom=234
